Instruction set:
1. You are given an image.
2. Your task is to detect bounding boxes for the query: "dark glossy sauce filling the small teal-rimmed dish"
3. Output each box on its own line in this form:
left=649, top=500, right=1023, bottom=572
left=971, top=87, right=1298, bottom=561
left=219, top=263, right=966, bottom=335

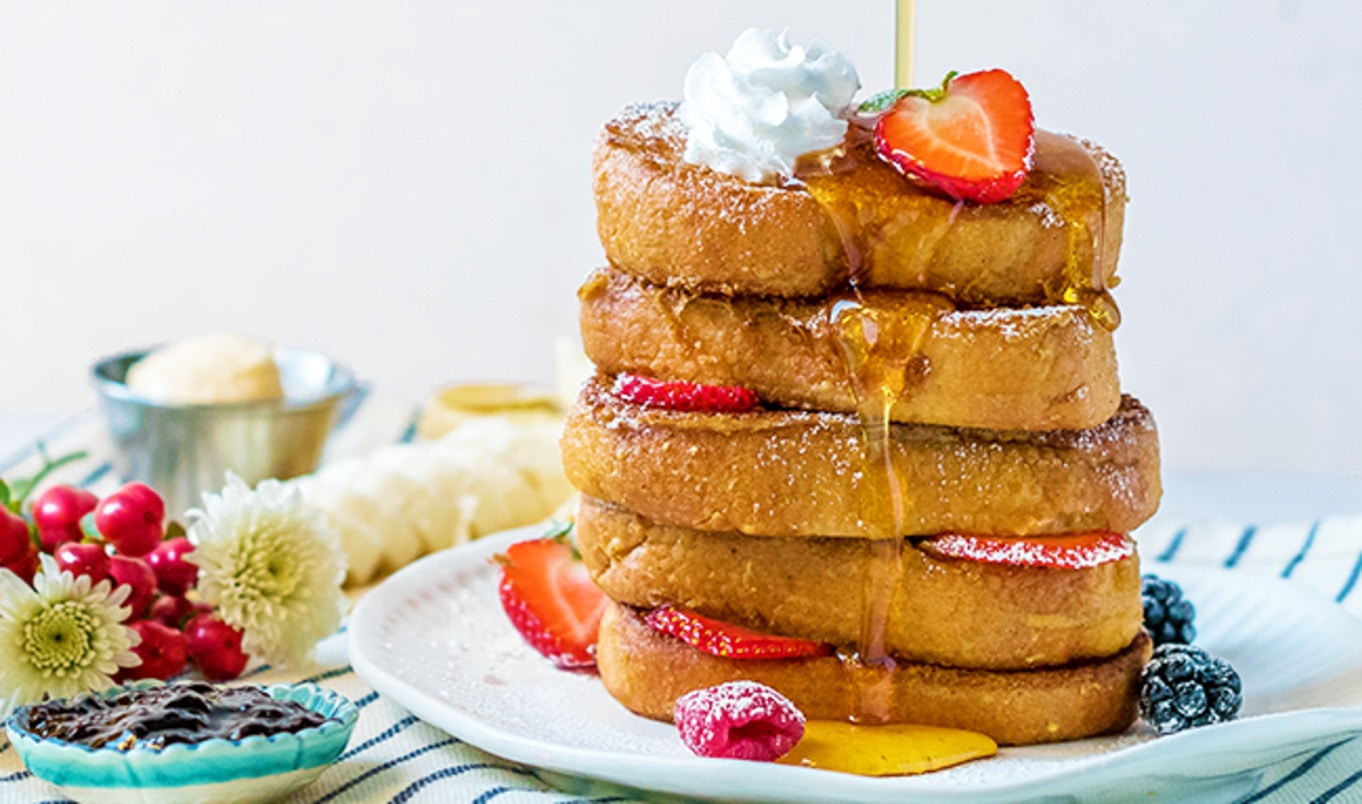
left=23, top=681, right=328, bottom=751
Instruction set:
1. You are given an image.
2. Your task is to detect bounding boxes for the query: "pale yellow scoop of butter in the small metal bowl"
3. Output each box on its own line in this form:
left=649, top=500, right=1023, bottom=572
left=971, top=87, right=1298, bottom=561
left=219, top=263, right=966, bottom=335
left=127, top=333, right=283, bottom=405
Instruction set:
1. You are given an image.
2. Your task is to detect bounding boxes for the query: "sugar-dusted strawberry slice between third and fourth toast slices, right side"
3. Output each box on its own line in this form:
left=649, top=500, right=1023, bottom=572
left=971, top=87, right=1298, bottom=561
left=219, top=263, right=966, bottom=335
left=921, top=530, right=1135, bottom=570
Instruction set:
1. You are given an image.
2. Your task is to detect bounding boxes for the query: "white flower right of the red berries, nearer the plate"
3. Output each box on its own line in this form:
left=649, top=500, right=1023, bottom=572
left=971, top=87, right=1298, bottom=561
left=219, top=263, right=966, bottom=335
left=185, top=473, right=346, bottom=665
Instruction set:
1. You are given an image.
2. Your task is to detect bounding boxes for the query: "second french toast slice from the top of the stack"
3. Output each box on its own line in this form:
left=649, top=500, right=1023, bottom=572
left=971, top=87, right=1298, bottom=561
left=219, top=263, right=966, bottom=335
left=577, top=268, right=1121, bottom=431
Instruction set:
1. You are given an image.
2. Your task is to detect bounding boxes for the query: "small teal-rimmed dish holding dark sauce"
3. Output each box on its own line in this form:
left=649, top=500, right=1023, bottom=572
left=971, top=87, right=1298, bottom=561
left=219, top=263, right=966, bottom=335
left=5, top=681, right=360, bottom=804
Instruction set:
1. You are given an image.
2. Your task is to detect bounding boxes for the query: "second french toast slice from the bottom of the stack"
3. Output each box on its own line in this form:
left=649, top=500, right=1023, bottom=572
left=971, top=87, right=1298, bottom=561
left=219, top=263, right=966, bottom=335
left=573, top=497, right=1144, bottom=670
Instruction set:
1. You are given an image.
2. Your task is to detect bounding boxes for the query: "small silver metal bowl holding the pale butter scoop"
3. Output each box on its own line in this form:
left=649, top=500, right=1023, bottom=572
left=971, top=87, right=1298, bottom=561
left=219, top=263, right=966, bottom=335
left=91, top=349, right=357, bottom=514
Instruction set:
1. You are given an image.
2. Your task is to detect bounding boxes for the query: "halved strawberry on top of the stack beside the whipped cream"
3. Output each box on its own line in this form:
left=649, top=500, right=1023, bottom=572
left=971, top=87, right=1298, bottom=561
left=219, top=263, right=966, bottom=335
left=874, top=69, right=1035, bottom=203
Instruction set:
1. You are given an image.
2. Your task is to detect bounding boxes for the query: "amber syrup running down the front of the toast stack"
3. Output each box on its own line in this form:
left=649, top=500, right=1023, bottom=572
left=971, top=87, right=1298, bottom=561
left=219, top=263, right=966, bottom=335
left=797, top=117, right=1120, bottom=724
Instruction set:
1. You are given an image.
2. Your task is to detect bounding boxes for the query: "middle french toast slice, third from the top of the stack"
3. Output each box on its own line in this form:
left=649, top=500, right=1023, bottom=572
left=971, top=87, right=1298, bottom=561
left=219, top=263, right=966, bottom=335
left=561, top=375, right=1160, bottom=537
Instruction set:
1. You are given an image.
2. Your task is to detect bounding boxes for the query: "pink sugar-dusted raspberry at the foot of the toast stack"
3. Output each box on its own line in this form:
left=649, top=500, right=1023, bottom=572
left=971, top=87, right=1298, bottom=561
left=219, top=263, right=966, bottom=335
left=671, top=681, right=804, bottom=762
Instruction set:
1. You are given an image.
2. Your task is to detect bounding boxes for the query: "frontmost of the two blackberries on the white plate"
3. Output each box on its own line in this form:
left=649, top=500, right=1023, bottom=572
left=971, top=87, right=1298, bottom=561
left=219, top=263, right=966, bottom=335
left=1140, top=645, right=1244, bottom=735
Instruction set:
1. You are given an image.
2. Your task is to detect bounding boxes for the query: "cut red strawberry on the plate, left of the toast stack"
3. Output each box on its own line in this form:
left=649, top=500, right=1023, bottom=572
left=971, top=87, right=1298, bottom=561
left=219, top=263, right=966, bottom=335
left=496, top=530, right=606, bottom=669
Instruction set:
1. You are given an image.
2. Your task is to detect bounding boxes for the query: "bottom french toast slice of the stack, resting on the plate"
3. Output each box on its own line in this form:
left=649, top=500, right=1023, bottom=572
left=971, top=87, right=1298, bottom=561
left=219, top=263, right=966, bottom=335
left=597, top=604, right=1151, bottom=745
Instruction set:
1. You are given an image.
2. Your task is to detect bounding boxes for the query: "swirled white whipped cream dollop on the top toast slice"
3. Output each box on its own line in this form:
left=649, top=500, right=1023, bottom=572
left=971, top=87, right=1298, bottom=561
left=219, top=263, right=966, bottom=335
left=681, top=29, right=861, bottom=183
